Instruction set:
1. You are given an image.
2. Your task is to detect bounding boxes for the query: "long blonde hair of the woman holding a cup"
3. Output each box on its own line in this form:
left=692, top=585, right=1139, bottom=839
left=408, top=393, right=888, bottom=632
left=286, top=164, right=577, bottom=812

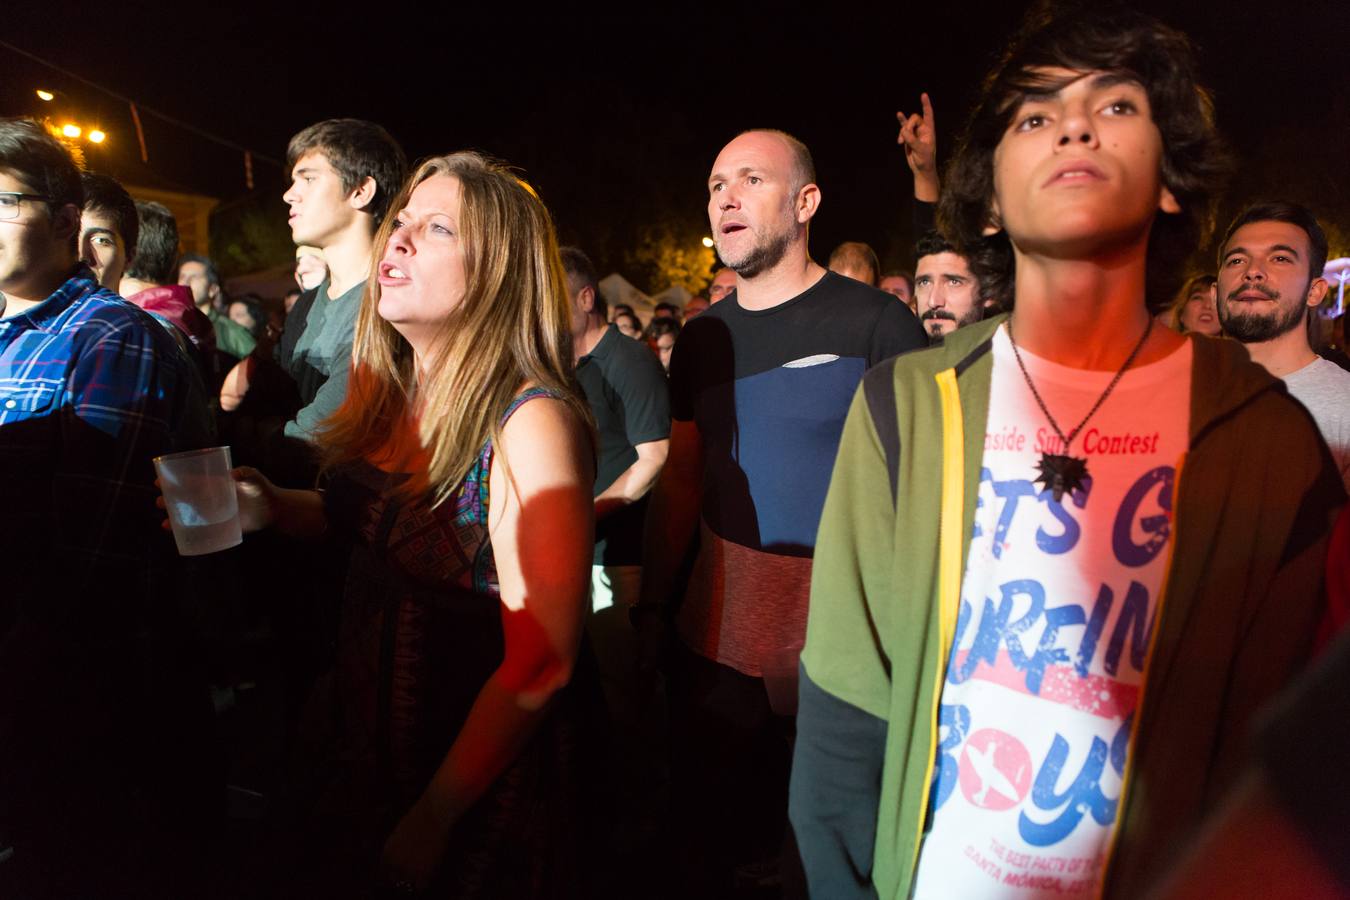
left=319, top=152, right=591, bottom=505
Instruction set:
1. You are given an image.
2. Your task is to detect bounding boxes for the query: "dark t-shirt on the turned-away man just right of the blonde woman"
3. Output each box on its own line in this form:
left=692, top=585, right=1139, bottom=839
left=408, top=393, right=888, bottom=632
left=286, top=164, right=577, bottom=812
left=576, top=325, right=671, bottom=565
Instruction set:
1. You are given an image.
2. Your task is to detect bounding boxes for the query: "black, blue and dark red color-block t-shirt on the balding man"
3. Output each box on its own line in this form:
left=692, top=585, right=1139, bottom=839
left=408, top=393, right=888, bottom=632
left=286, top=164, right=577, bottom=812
left=671, top=273, right=926, bottom=676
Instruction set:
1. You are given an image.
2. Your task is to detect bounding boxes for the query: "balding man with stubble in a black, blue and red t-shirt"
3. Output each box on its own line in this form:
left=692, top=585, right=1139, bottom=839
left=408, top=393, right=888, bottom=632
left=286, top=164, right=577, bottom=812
left=635, top=131, right=925, bottom=896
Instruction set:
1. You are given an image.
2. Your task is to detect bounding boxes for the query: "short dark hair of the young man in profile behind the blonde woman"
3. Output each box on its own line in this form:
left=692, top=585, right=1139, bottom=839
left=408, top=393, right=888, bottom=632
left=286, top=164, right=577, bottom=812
left=286, top=119, right=408, bottom=225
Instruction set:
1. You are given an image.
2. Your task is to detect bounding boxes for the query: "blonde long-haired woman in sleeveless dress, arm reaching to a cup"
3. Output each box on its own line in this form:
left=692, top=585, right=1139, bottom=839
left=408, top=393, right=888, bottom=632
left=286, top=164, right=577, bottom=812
left=224, top=152, right=594, bottom=897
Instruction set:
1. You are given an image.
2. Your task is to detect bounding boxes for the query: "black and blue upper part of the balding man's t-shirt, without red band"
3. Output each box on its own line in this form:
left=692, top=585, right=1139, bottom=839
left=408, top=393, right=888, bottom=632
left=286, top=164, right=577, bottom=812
left=671, top=273, right=927, bottom=557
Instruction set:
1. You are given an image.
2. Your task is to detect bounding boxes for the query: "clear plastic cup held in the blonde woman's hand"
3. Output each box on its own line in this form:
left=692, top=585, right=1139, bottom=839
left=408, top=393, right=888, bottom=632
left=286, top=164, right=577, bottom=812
left=155, top=447, right=244, bottom=556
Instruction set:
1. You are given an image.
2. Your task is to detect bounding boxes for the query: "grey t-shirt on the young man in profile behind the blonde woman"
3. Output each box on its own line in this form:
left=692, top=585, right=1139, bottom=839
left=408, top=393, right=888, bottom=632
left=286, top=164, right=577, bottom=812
left=277, top=281, right=366, bottom=440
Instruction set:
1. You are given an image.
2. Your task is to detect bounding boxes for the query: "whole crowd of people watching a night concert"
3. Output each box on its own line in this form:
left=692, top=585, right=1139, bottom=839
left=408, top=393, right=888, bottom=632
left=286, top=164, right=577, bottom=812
left=0, top=7, right=1350, bottom=900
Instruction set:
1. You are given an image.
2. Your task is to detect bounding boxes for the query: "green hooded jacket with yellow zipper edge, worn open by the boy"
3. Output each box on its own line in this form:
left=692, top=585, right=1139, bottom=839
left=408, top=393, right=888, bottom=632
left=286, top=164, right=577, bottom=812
left=790, top=316, right=1345, bottom=900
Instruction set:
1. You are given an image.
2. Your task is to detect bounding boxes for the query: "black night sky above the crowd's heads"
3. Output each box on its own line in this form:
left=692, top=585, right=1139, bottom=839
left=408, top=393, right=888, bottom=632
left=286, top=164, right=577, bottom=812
left=0, top=0, right=1350, bottom=287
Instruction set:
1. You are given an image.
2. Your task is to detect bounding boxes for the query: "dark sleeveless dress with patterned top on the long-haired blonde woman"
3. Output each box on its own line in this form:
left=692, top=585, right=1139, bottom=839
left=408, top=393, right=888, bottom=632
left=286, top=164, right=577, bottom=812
left=308, top=389, right=585, bottom=899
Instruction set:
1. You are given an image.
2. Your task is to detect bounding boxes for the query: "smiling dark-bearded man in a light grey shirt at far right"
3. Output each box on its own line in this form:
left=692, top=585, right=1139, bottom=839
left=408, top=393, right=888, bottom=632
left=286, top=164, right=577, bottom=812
left=1211, top=202, right=1350, bottom=484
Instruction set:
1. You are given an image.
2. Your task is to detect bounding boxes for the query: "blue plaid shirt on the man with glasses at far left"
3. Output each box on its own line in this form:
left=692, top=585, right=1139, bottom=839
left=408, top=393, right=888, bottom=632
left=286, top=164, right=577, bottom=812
left=0, top=266, right=207, bottom=598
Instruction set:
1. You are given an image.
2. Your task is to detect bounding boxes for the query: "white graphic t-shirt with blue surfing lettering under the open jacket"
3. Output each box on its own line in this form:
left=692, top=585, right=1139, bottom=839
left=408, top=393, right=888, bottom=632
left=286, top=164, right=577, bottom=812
left=913, top=328, right=1191, bottom=900
